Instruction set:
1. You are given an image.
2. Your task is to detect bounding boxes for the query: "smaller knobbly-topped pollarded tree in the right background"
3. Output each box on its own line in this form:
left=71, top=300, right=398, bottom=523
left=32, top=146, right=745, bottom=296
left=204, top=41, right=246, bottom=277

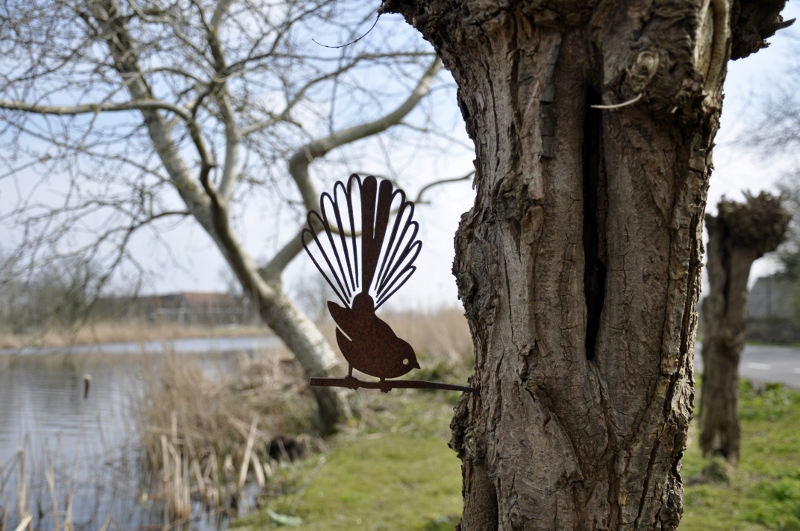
left=700, top=193, right=790, bottom=466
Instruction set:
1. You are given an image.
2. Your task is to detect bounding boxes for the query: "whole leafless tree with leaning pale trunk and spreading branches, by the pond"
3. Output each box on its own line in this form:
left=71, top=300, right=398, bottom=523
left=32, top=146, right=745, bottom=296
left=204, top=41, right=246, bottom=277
left=0, top=0, right=468, bottom=429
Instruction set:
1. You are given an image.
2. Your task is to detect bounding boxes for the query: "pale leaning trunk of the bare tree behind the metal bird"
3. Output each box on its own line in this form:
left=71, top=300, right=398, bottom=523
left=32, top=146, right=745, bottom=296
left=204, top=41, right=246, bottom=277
left=88, top=0, right=354, bottom=432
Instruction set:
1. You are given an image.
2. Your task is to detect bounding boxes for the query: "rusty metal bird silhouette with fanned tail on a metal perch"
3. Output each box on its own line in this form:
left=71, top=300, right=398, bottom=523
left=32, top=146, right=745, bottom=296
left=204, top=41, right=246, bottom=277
left=302, top=174, right=474, bottom=392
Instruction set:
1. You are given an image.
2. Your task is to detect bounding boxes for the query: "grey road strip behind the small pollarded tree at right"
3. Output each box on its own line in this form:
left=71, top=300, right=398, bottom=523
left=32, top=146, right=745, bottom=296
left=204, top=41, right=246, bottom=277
left=694, top=343, right=800, bottom=388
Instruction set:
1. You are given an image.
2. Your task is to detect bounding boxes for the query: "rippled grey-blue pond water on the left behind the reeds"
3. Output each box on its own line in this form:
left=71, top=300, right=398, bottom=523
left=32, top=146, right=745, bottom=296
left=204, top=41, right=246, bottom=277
left=0, top=338, right=275, bottom=529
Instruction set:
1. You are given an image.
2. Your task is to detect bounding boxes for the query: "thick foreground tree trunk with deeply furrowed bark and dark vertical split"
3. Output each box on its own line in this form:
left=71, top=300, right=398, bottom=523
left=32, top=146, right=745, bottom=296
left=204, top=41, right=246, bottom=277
left=383, top=0, right=783, bottom=530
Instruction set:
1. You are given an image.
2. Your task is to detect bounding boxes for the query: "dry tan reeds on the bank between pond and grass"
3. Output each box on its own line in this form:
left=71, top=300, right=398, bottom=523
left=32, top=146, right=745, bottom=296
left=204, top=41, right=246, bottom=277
left=132, top=350, right=314, bottom=524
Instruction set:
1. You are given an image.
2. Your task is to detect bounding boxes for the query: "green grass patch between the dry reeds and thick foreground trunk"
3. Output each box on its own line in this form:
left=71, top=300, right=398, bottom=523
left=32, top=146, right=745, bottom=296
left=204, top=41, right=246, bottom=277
left=234, top=390, right=462, bottom=531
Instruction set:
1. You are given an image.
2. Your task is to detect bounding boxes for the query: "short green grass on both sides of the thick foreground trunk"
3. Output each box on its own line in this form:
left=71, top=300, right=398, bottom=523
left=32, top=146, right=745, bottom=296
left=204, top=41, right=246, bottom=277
left=234, top=382, right=800, bottom=531
